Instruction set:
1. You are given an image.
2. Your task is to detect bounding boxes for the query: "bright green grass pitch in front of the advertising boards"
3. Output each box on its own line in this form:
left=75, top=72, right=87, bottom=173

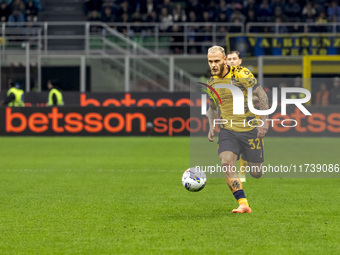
left=0, top=137, right=340, bottom=254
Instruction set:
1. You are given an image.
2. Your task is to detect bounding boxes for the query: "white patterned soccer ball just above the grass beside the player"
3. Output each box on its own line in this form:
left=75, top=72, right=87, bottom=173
left=182, top=167, right=207, bottom=192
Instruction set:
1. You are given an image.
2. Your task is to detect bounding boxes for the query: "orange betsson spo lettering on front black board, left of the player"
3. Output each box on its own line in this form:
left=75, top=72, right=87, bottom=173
left=6, top=107, right=203, bottom=136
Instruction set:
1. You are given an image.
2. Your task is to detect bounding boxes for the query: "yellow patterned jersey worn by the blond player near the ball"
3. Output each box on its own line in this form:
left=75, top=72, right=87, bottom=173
left=208, top=66, right=259, bottom=132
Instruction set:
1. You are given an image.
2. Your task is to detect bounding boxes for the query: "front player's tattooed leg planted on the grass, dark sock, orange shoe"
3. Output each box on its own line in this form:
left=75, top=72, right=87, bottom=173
left=219, top=151, right=251, bottom=213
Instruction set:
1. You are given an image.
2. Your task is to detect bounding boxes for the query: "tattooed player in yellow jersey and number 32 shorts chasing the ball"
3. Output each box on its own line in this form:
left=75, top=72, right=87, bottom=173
left=207, top=46, right=268, bottom=213
